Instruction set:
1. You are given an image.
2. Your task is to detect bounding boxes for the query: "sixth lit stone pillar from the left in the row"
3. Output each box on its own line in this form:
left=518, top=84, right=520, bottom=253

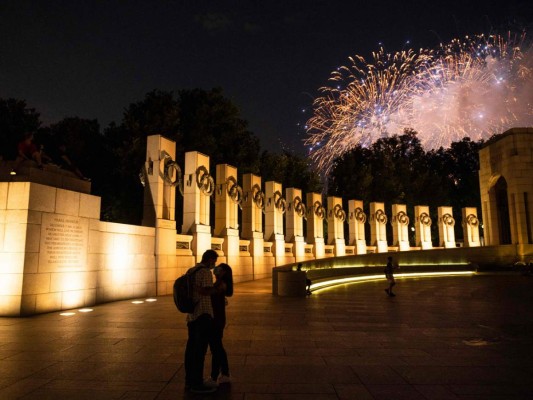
left=285, top=188, right=307, bottom=262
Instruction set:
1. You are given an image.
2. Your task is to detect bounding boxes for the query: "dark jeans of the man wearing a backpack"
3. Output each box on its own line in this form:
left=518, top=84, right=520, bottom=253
left=185, top=314, right=213, bottom=387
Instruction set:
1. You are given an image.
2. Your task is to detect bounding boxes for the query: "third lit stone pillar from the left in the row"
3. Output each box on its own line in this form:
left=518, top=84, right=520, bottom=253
left=213, top=164, right=243, bottom=264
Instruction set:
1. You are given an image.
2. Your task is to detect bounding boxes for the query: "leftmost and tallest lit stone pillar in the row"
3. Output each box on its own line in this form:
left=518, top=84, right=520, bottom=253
left=141, top=135, right=181, bottom=230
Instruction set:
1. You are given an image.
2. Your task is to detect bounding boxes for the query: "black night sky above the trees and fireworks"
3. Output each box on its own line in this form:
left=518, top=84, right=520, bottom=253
left=0, top=0, right=533, bottom=152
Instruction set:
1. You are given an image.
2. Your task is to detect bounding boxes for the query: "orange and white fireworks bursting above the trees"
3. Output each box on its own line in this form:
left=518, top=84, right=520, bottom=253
left=305, top=34, right=533, bottom=173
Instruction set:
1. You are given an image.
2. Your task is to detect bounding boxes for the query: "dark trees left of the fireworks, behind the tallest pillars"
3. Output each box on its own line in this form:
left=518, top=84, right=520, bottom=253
left=0, top=88, right=322, bottom=226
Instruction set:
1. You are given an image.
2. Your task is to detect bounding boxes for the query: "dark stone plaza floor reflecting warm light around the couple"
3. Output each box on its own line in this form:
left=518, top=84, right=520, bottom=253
left=0, top=274, right=533, bottom=400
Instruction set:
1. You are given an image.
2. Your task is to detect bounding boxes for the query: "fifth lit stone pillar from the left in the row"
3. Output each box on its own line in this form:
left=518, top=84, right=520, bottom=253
left=264, top=181, right=287, bottom=265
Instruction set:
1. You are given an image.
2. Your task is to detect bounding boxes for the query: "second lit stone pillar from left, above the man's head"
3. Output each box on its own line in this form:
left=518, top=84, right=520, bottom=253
left=181, top=151, right=211, bottom=261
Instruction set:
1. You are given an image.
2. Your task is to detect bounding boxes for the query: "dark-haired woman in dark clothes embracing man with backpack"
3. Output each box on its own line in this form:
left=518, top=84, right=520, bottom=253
left=209, top=264, right=233, bottom=384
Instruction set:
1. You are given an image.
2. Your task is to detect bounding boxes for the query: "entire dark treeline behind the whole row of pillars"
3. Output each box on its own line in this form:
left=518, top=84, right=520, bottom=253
left=0, top=94, right=481, bottom=238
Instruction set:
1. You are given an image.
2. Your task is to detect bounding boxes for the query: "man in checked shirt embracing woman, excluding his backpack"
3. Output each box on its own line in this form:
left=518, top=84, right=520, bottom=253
left=185, top=250, right=218, bottom=393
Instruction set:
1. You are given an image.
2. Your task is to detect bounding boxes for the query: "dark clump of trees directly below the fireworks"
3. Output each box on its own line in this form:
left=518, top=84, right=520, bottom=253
left=328, top=130, right=483, bottom=243
